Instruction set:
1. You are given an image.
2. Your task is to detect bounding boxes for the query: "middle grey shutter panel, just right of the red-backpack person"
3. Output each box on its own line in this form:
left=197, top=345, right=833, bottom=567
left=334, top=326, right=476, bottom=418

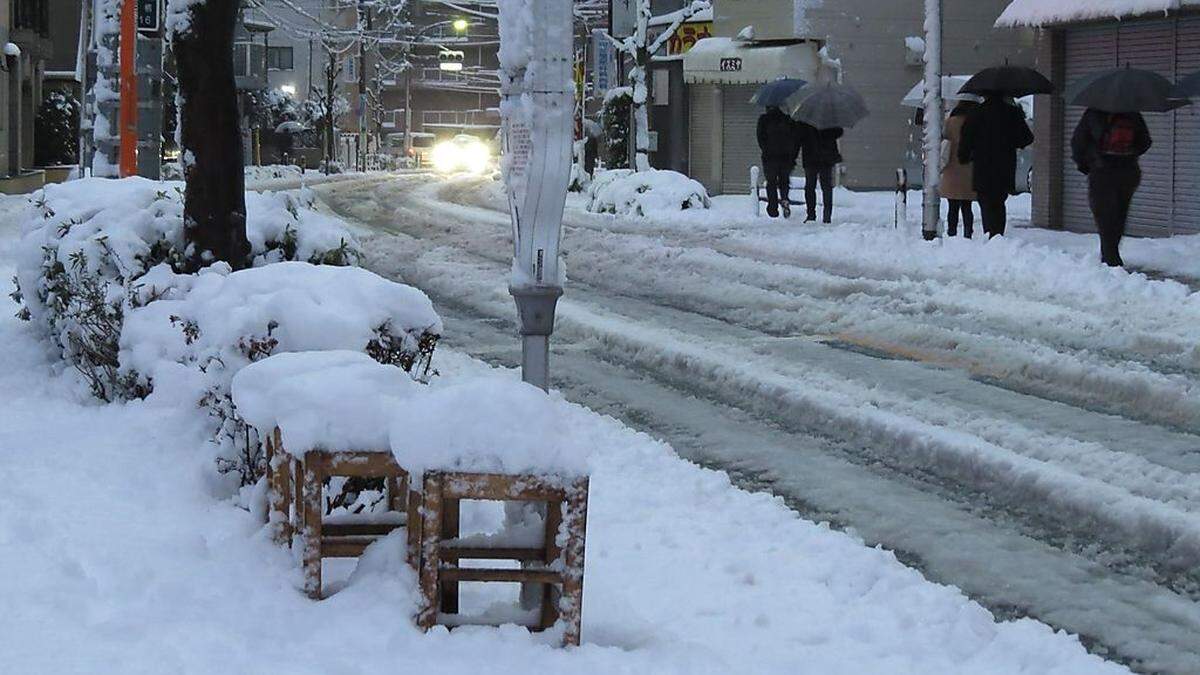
left=1117, top=19, right=1175, bottom=234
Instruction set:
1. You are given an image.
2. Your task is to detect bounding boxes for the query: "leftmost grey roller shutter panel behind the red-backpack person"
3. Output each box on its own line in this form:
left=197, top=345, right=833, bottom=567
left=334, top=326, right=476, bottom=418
left=1062, top=26, right=1117, bottom=232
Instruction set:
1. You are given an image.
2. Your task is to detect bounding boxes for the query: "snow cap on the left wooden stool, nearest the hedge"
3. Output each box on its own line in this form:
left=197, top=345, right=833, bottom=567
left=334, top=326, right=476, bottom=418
left=232, top=351, right=425, bottom=452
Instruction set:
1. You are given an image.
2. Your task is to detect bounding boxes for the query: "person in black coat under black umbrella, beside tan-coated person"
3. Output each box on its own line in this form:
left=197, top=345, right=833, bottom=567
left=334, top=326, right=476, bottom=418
left=958, top=66, right=1054, bottom=238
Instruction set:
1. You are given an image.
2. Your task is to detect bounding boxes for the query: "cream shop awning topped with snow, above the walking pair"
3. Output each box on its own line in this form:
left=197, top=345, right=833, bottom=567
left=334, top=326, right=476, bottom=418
left=683, top=37, right=821, bottom=84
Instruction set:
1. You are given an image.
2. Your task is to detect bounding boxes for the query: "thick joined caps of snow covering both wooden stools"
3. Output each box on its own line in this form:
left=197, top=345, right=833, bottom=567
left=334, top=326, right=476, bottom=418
left=232, top=351, right=595, bottom=477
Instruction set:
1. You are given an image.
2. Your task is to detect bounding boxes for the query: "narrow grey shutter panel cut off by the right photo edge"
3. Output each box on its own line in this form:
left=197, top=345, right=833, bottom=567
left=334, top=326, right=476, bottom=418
left=1174, top=17, right=1200, bottom=234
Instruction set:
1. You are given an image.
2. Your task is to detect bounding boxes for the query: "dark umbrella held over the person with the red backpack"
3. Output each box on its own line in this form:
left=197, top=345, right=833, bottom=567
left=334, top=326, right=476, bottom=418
left=1064, top=66, right=1188, bottom=113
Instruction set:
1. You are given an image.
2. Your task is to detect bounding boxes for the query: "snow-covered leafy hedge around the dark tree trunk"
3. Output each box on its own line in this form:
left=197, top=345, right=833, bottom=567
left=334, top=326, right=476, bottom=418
left=13, top=178, right=442, bottom=483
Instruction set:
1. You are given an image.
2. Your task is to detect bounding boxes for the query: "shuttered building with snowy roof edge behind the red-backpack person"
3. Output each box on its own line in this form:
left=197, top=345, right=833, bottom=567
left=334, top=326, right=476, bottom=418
left=1000, top=0, right=1200, bottom=235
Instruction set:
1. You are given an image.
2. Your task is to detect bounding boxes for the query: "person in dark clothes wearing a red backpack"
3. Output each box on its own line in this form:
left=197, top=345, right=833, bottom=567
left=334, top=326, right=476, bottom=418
left=1070, top=108, right=1153, bottom=267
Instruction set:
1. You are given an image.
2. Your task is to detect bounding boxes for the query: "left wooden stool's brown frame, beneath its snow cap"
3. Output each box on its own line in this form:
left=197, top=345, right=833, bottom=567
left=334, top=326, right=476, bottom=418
left=266, top=428, right=421, bottom=599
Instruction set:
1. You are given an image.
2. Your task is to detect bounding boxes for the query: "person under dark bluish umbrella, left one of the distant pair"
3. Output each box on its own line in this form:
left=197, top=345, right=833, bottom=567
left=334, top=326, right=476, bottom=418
left=750, top=78, right=805, bottom=217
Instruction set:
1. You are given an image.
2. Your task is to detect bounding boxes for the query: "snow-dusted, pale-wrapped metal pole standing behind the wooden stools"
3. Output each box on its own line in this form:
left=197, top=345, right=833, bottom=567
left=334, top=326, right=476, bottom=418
left=497, top=0, right=575, bottom=389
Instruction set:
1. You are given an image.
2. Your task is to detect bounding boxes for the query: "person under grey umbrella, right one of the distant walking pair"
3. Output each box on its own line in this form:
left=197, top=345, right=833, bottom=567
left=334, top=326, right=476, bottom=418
left=787, top=82, right=869, bottom=223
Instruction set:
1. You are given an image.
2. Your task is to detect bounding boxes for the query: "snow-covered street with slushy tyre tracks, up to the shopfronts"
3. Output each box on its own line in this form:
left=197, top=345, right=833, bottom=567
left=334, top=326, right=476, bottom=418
left=318, top=171, right=1200, bottom=673
